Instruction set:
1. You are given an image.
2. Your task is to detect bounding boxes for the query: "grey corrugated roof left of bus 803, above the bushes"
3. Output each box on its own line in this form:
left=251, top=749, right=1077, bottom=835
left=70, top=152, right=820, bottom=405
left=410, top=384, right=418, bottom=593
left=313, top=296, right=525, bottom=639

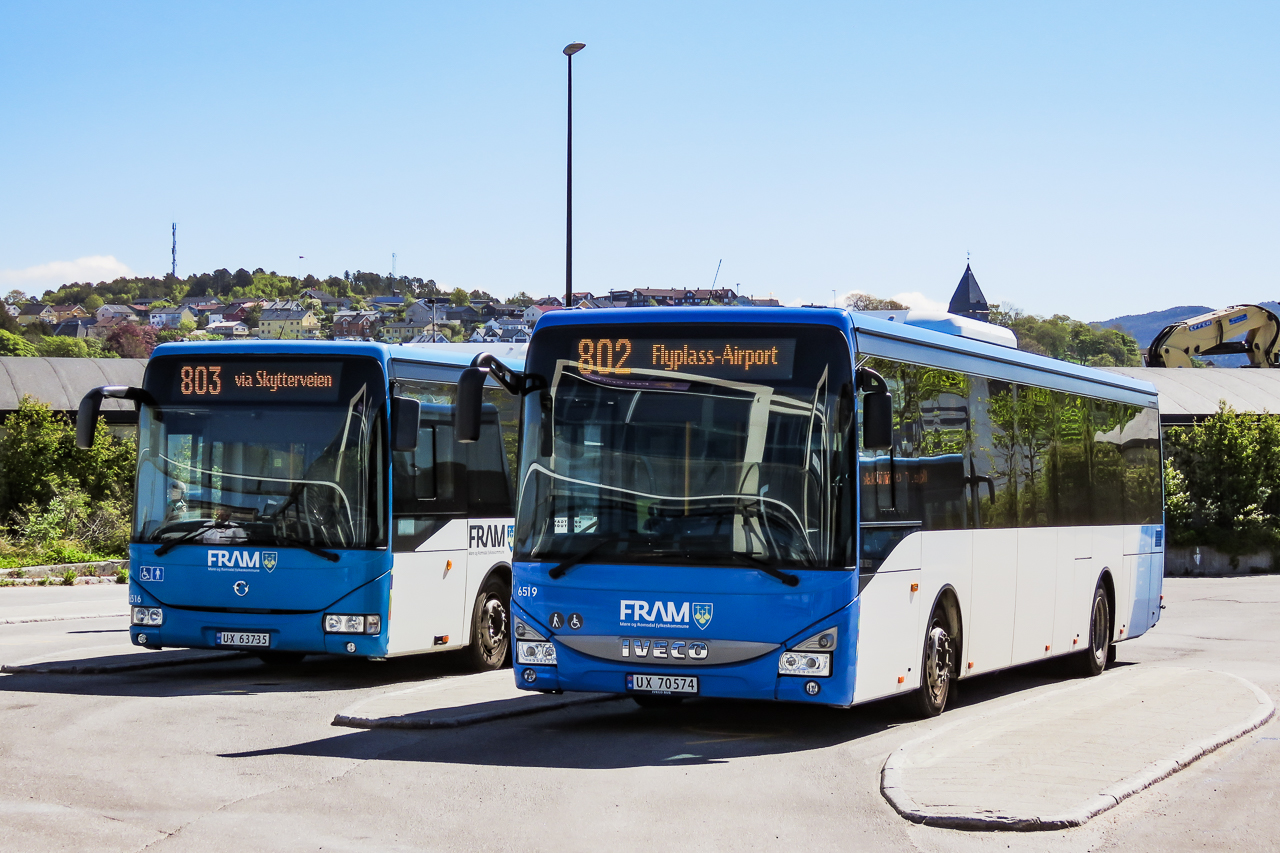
left=0, top=357, right=147, bottom=416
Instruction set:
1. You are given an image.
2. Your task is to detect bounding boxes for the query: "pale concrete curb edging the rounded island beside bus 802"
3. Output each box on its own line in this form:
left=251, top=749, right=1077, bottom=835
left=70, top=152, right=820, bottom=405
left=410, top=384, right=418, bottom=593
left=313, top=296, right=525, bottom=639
left=881, top=670, right=1276, bottom=831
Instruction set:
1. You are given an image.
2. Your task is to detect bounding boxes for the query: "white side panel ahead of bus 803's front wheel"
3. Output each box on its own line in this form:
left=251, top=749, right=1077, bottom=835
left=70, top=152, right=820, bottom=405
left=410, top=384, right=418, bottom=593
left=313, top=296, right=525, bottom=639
left=387, top=519, right=470, bottom=656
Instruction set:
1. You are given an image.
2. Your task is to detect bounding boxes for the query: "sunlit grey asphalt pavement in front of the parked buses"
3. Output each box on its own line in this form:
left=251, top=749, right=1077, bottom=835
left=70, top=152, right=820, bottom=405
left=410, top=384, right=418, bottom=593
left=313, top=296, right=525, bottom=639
left=0, top=576, right=1280, bottom=852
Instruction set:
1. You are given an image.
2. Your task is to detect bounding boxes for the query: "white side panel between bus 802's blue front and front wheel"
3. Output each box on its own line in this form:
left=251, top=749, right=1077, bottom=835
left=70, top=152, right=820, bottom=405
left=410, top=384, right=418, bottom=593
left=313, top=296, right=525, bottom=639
left=854, top=533, right=922, bottom=703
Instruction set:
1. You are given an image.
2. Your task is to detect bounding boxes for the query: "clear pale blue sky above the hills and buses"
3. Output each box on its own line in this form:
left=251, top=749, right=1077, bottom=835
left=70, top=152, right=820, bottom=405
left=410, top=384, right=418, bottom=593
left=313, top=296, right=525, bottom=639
left=0, top=0, right=1280, bottom=320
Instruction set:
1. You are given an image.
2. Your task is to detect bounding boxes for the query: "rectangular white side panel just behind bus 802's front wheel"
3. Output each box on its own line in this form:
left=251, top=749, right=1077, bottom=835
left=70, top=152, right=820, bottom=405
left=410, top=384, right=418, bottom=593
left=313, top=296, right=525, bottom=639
left=965, top=529, right=1018, bottom=675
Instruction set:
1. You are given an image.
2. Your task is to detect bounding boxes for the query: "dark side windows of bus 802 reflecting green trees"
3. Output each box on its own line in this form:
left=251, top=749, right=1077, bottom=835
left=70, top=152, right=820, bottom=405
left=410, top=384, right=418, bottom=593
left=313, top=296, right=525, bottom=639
left=859, top=359, right=1162, bottom=545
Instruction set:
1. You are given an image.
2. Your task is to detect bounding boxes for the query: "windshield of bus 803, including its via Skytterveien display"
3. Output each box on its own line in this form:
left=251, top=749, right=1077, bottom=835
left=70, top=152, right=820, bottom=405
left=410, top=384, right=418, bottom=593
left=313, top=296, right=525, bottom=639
left=133, top=356, right=387, bottom=549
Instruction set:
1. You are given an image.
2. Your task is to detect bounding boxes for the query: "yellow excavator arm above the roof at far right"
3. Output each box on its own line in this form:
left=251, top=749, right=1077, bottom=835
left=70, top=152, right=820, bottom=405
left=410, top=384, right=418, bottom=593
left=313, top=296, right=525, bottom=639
left=1147, top=305, right=1280, bottom=368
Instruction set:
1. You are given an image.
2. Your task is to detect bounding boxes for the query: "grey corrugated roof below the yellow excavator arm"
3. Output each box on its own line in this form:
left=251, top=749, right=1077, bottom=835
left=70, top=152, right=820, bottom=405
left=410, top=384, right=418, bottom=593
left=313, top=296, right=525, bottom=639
left=1103, top=368, right=1280, bottom=424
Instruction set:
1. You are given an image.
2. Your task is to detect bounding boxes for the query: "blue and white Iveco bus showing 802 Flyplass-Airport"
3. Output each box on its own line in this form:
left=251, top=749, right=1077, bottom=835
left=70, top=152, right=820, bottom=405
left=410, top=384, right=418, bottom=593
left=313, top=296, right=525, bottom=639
left=458, top=307, right=1164, bottom=715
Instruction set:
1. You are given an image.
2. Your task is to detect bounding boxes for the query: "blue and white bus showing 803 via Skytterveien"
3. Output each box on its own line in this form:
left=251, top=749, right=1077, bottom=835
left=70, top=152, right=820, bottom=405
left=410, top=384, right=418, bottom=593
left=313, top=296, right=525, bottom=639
left=78, top=342, right=524, bottom=669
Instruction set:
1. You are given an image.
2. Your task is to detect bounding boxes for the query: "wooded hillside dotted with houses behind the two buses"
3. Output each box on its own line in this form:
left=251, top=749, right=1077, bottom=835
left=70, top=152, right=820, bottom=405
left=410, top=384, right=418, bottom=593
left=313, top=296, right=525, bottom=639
left=0, top=269, right=778, bottom=357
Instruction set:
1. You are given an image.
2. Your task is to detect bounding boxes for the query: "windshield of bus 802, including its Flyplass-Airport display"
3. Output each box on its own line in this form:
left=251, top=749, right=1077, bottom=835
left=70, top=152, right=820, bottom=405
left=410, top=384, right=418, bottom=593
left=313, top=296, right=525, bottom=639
left=516, top=324, right=852, bottom=567
